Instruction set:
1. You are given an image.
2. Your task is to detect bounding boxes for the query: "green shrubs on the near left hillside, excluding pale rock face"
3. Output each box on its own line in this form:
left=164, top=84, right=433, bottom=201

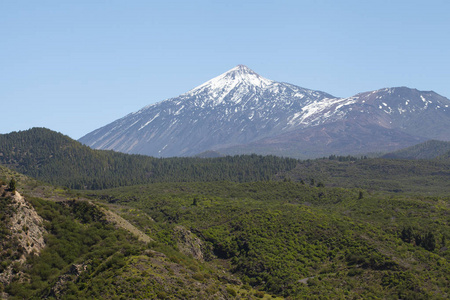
left=0, top=185, right=265, bottom=299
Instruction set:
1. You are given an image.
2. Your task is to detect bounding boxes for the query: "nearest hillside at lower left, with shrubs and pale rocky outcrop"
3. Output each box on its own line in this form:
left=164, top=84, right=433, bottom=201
left=0, top=167, right=272, bottom=299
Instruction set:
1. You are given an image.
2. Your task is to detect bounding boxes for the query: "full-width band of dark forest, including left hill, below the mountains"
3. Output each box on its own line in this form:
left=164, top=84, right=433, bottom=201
left=0, top=128, right=450, bottom=195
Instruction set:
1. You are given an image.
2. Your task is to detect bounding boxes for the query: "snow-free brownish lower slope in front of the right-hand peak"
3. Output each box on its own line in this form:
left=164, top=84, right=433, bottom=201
left=219, top=120, right=425, bottom=159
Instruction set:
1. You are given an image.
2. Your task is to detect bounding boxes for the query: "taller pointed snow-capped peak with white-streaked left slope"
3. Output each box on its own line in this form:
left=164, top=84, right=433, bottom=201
left=79, top=65, right=336, bottom=157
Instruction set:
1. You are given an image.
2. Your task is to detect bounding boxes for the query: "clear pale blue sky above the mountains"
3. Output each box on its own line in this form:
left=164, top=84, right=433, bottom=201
left=0, top=0, right=450, bottom=139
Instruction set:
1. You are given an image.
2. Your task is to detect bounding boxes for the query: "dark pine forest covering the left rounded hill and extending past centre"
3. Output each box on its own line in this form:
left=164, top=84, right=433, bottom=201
left=0, top=128, right=297, bottom=189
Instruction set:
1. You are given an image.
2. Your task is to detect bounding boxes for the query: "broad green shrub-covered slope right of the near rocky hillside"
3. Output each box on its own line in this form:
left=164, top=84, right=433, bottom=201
left=91, top=182, right=450, bottom=299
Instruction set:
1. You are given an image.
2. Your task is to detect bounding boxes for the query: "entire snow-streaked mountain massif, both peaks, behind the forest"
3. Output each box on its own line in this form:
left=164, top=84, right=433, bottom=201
left=79, top=65, right=450, bottom=158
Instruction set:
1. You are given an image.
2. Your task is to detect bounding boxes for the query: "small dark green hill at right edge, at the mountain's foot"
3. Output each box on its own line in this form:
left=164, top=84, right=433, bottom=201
left=383, top=140, right=450, bottom=159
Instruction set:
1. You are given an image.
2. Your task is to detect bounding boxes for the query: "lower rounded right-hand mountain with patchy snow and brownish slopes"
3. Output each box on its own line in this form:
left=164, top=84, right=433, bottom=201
left=214, top=87, right=450, bottom=158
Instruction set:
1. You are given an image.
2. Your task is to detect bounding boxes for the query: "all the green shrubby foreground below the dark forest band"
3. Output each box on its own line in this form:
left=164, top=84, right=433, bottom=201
left=0, top=167, right=450, bottom=299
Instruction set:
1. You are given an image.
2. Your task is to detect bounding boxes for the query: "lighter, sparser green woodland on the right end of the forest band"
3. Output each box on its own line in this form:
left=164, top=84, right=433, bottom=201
left=283, top=158, right=450, bottom=195
